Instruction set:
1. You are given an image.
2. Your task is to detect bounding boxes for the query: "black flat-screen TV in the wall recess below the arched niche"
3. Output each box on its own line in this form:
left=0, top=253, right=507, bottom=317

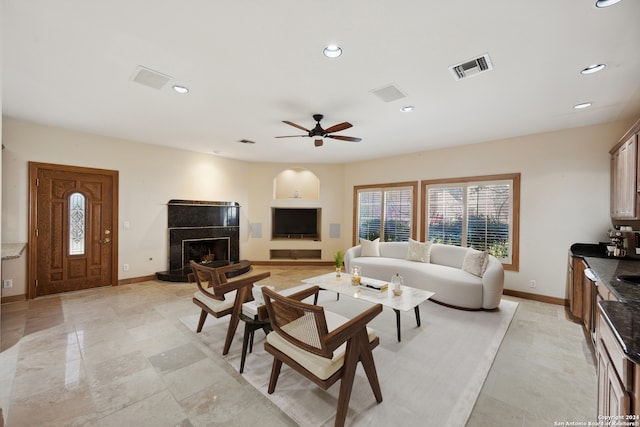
left=271, top=208, right=321, bottom=240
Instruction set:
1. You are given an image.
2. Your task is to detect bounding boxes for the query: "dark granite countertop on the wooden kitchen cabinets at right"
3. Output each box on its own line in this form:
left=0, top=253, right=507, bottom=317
left=571, top=244, right=640, bottom=365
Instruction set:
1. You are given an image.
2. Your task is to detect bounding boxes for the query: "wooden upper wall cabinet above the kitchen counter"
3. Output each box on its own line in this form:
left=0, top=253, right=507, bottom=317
left=609, top=120, right=640, bottom=219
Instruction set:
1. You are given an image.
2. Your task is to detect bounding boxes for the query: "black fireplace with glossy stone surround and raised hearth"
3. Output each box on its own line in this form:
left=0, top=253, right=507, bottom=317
left=156, top=200, right=250, bottom=282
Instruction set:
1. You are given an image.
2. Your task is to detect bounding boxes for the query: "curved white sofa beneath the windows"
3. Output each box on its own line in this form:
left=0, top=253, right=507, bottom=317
left=344, top=242, right=504, bottom=310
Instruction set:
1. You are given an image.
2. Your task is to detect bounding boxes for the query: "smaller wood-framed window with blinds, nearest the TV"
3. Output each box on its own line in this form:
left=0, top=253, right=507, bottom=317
left=354, top=182, right=418, bottom=244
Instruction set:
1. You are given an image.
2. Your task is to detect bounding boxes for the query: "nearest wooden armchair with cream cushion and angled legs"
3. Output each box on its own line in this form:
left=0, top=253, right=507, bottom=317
left=262, top=286, right=382, bottom=426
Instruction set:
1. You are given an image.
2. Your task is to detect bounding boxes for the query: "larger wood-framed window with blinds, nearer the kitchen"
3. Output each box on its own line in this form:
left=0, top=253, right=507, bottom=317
left=422, top=174, right=520, bottom=270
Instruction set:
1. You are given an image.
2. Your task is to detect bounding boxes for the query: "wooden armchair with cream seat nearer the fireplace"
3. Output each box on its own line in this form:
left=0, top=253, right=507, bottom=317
left=189, top=260, right=271, bottom=354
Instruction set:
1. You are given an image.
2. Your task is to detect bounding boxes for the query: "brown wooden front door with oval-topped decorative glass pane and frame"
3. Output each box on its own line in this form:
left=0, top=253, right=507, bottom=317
left=28, top=162, right=118, bottom=298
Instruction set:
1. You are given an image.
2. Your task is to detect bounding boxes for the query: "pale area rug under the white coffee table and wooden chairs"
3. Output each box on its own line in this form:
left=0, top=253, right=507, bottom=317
left=181, top=291, right=518, bottom=427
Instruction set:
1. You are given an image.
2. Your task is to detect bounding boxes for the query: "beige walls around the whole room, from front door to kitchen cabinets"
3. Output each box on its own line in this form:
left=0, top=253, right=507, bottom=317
left=2, top=113, right=632, bottom=298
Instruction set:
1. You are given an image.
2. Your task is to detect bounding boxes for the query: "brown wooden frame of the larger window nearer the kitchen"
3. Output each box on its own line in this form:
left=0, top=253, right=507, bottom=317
left=420, top=173, right=520, bottom=271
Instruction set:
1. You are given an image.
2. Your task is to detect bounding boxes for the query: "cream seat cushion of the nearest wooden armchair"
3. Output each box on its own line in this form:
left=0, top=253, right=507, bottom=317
left=267, top=311, right=377, bottom=380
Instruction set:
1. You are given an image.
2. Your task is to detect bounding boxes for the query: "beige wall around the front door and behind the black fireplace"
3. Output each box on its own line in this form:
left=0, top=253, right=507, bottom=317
left=2, top=117, right=249, bottom=297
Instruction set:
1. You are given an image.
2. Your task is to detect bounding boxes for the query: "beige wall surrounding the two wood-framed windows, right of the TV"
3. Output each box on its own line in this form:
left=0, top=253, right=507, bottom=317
left=344, top=122, right=632, bottom=298
